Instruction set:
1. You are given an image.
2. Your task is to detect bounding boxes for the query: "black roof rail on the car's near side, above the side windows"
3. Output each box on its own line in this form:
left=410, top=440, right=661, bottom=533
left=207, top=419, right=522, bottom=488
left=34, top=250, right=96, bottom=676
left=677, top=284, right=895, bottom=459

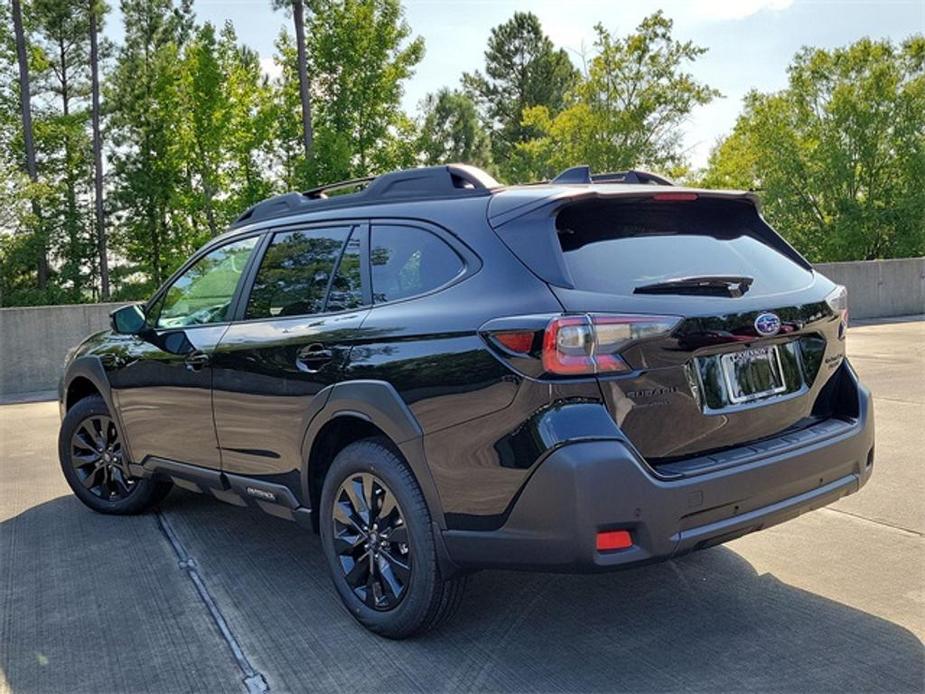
left=230, top=164, right=501, bottom=229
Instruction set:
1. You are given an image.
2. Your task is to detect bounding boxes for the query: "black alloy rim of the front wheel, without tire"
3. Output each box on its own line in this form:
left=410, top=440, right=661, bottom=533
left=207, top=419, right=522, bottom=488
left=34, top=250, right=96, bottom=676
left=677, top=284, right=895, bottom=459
left=70, top=414, right=136, bottom=501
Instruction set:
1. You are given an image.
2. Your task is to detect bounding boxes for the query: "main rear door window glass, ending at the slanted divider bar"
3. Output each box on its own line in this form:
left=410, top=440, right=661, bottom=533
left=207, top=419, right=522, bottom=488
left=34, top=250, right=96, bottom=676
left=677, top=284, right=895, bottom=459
left=244, top=227, right=350, bottom=319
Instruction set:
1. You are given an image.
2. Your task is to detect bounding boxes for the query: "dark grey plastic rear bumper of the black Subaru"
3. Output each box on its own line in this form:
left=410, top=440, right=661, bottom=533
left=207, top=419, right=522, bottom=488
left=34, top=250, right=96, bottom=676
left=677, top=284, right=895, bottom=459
left=444, top=372, right=874, bottom=572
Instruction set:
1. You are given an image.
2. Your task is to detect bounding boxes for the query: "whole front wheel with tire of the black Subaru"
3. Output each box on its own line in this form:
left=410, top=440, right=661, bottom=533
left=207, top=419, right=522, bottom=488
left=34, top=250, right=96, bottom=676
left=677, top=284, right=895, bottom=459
left=58, top=395, right=173, bottom=515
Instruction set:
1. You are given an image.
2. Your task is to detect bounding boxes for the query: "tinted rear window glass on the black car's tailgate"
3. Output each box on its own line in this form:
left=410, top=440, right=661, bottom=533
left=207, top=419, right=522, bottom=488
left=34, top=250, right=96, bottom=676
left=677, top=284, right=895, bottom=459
left=556, top=200, right=812, bottom=294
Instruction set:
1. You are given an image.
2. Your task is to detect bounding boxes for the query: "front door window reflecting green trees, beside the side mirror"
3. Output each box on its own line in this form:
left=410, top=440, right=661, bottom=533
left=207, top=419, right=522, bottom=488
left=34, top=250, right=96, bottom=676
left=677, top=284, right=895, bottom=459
left=152, top=236, right=258, bottom=328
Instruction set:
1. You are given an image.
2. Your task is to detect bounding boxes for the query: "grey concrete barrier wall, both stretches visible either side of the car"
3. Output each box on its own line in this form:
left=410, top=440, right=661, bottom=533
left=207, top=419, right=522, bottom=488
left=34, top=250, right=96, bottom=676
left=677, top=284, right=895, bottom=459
left=0, top=258, right=925, bottom=397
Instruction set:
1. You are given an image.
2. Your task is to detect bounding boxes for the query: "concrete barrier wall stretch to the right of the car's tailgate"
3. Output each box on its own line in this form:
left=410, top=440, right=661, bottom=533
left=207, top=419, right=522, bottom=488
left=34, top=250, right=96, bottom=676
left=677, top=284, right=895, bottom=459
left=816, top=258, right=925, bottom=318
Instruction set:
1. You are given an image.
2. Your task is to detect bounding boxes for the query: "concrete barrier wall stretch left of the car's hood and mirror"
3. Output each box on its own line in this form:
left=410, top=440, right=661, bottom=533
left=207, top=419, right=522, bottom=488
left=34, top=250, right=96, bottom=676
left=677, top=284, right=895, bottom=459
left=0, top=304, right=124, bottom=397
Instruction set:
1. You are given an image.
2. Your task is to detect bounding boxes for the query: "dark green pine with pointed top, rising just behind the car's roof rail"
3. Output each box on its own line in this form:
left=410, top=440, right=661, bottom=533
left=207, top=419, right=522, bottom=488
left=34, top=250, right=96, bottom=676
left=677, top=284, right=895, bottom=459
left=463, top=12, right=578, bottom=173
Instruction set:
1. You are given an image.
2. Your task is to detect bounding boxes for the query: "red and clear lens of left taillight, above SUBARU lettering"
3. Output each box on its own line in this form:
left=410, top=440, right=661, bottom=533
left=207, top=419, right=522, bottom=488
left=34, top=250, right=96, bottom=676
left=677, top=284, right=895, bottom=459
left=543, top=314, right=680, bottom=376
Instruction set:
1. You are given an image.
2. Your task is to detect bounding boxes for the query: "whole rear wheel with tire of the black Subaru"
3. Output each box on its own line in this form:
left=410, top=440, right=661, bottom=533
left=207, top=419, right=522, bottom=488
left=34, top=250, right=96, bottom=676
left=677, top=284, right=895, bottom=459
left=318, top=438, right=465, bottom=639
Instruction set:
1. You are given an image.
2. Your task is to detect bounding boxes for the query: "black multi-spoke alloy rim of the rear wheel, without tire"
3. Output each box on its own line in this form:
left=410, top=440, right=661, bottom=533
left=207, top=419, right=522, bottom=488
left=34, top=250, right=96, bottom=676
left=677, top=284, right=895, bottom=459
left=332, top=472, right=412, bottom=611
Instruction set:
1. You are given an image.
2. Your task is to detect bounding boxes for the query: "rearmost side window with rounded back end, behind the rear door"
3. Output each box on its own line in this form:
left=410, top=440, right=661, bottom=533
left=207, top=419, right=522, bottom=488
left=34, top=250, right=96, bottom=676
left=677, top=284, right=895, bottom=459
left=369, top=225, right=463, bottom=303
